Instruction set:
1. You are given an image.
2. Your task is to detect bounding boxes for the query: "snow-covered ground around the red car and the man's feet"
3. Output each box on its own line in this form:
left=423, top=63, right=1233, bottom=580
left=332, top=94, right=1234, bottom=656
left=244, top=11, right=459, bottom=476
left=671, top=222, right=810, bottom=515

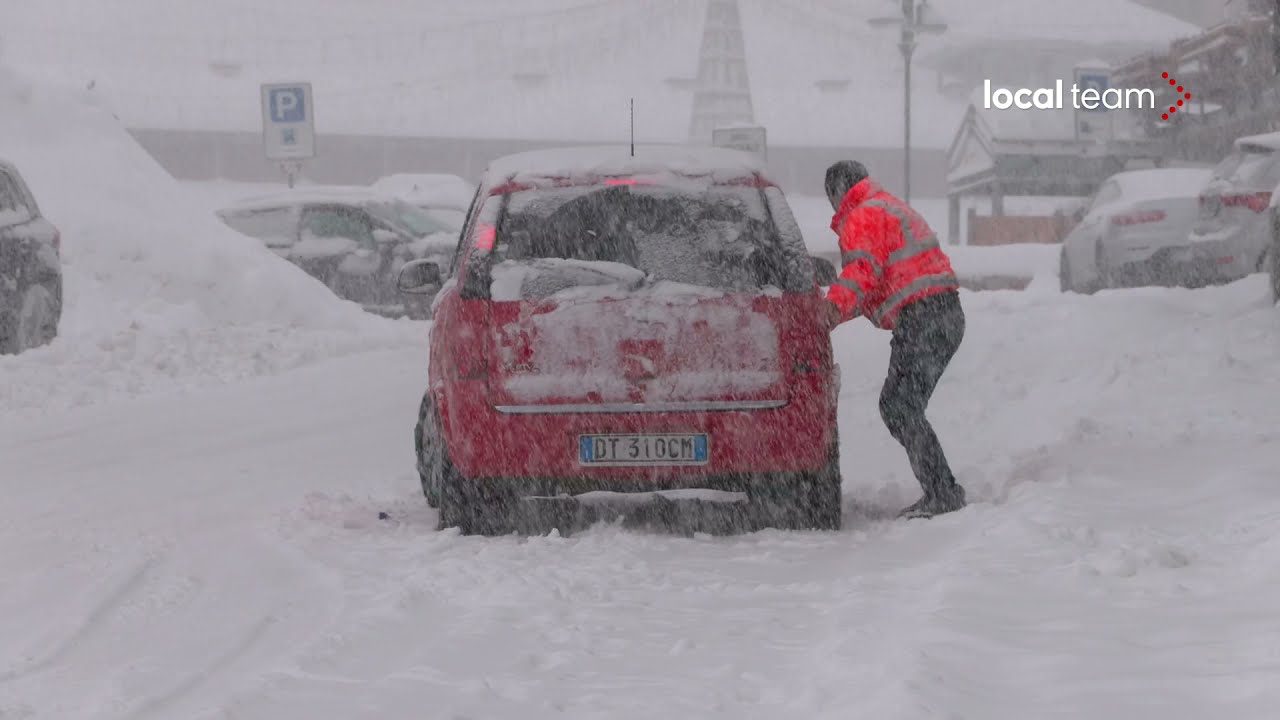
left=0, top=277, right=1280, bottom=720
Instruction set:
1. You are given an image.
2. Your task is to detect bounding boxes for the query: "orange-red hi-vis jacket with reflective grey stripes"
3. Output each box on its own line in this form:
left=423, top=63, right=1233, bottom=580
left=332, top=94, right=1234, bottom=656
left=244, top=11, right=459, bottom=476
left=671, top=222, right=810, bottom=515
left=827, top=178, right=960, bottom=329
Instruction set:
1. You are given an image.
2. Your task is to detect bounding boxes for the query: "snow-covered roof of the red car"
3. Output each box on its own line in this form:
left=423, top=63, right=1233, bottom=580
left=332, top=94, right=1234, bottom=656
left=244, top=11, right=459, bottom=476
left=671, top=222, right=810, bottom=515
left=478, top=145, right=765, bottom=178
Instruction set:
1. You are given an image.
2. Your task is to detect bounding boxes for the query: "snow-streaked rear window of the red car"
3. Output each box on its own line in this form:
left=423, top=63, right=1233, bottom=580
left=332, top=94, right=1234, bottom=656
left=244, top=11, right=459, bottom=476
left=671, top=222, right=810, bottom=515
left=476, top=183, right=813, bottom=297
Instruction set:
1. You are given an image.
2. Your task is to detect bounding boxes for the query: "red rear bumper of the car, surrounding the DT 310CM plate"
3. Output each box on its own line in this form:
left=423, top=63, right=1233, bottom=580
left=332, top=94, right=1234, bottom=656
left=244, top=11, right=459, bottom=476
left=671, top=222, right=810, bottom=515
left=440, top=378, right=836, bottom=479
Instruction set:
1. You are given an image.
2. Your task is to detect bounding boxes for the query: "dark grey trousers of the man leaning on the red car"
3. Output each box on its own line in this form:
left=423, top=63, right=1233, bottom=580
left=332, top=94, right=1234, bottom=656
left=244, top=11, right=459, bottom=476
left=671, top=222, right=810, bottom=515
left=881, top=292, right=965, bottom=497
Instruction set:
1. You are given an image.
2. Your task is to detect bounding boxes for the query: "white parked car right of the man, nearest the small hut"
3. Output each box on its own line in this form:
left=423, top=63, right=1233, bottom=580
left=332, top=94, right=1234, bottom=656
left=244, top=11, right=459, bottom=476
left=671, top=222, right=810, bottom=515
left=1059, top=168, right=1212, bottom=293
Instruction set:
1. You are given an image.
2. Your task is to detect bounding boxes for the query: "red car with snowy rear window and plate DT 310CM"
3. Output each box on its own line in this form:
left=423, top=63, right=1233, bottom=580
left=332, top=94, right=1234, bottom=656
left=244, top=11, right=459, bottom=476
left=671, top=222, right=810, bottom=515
left=398, top=147, right=841, bottom=534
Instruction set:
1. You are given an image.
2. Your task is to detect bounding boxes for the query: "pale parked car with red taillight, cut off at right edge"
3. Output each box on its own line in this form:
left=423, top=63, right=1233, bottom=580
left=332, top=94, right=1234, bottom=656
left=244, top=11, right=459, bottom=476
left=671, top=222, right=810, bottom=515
left=1189, top=132, right=1280, bottom=279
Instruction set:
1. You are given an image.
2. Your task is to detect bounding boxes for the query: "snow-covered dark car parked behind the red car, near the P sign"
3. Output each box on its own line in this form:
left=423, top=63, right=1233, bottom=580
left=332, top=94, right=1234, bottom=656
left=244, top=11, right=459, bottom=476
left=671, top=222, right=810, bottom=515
left=218, top=188, right=461, bottom=319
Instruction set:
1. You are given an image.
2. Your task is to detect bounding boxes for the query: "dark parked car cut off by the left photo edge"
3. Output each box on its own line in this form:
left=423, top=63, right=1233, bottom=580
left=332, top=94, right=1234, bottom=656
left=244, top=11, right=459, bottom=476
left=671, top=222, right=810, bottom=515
left=0, top=160, right=63, bottom=355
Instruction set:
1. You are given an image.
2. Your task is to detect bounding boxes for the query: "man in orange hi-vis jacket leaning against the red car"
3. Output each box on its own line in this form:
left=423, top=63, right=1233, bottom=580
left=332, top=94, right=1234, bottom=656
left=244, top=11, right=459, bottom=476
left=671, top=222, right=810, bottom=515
left=826, top=160, right=965, bottom=518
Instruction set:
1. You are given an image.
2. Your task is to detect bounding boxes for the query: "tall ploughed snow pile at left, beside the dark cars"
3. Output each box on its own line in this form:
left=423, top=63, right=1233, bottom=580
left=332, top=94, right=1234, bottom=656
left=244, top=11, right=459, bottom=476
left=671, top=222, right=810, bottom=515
left=0, top=69, right=404, bottom=409
